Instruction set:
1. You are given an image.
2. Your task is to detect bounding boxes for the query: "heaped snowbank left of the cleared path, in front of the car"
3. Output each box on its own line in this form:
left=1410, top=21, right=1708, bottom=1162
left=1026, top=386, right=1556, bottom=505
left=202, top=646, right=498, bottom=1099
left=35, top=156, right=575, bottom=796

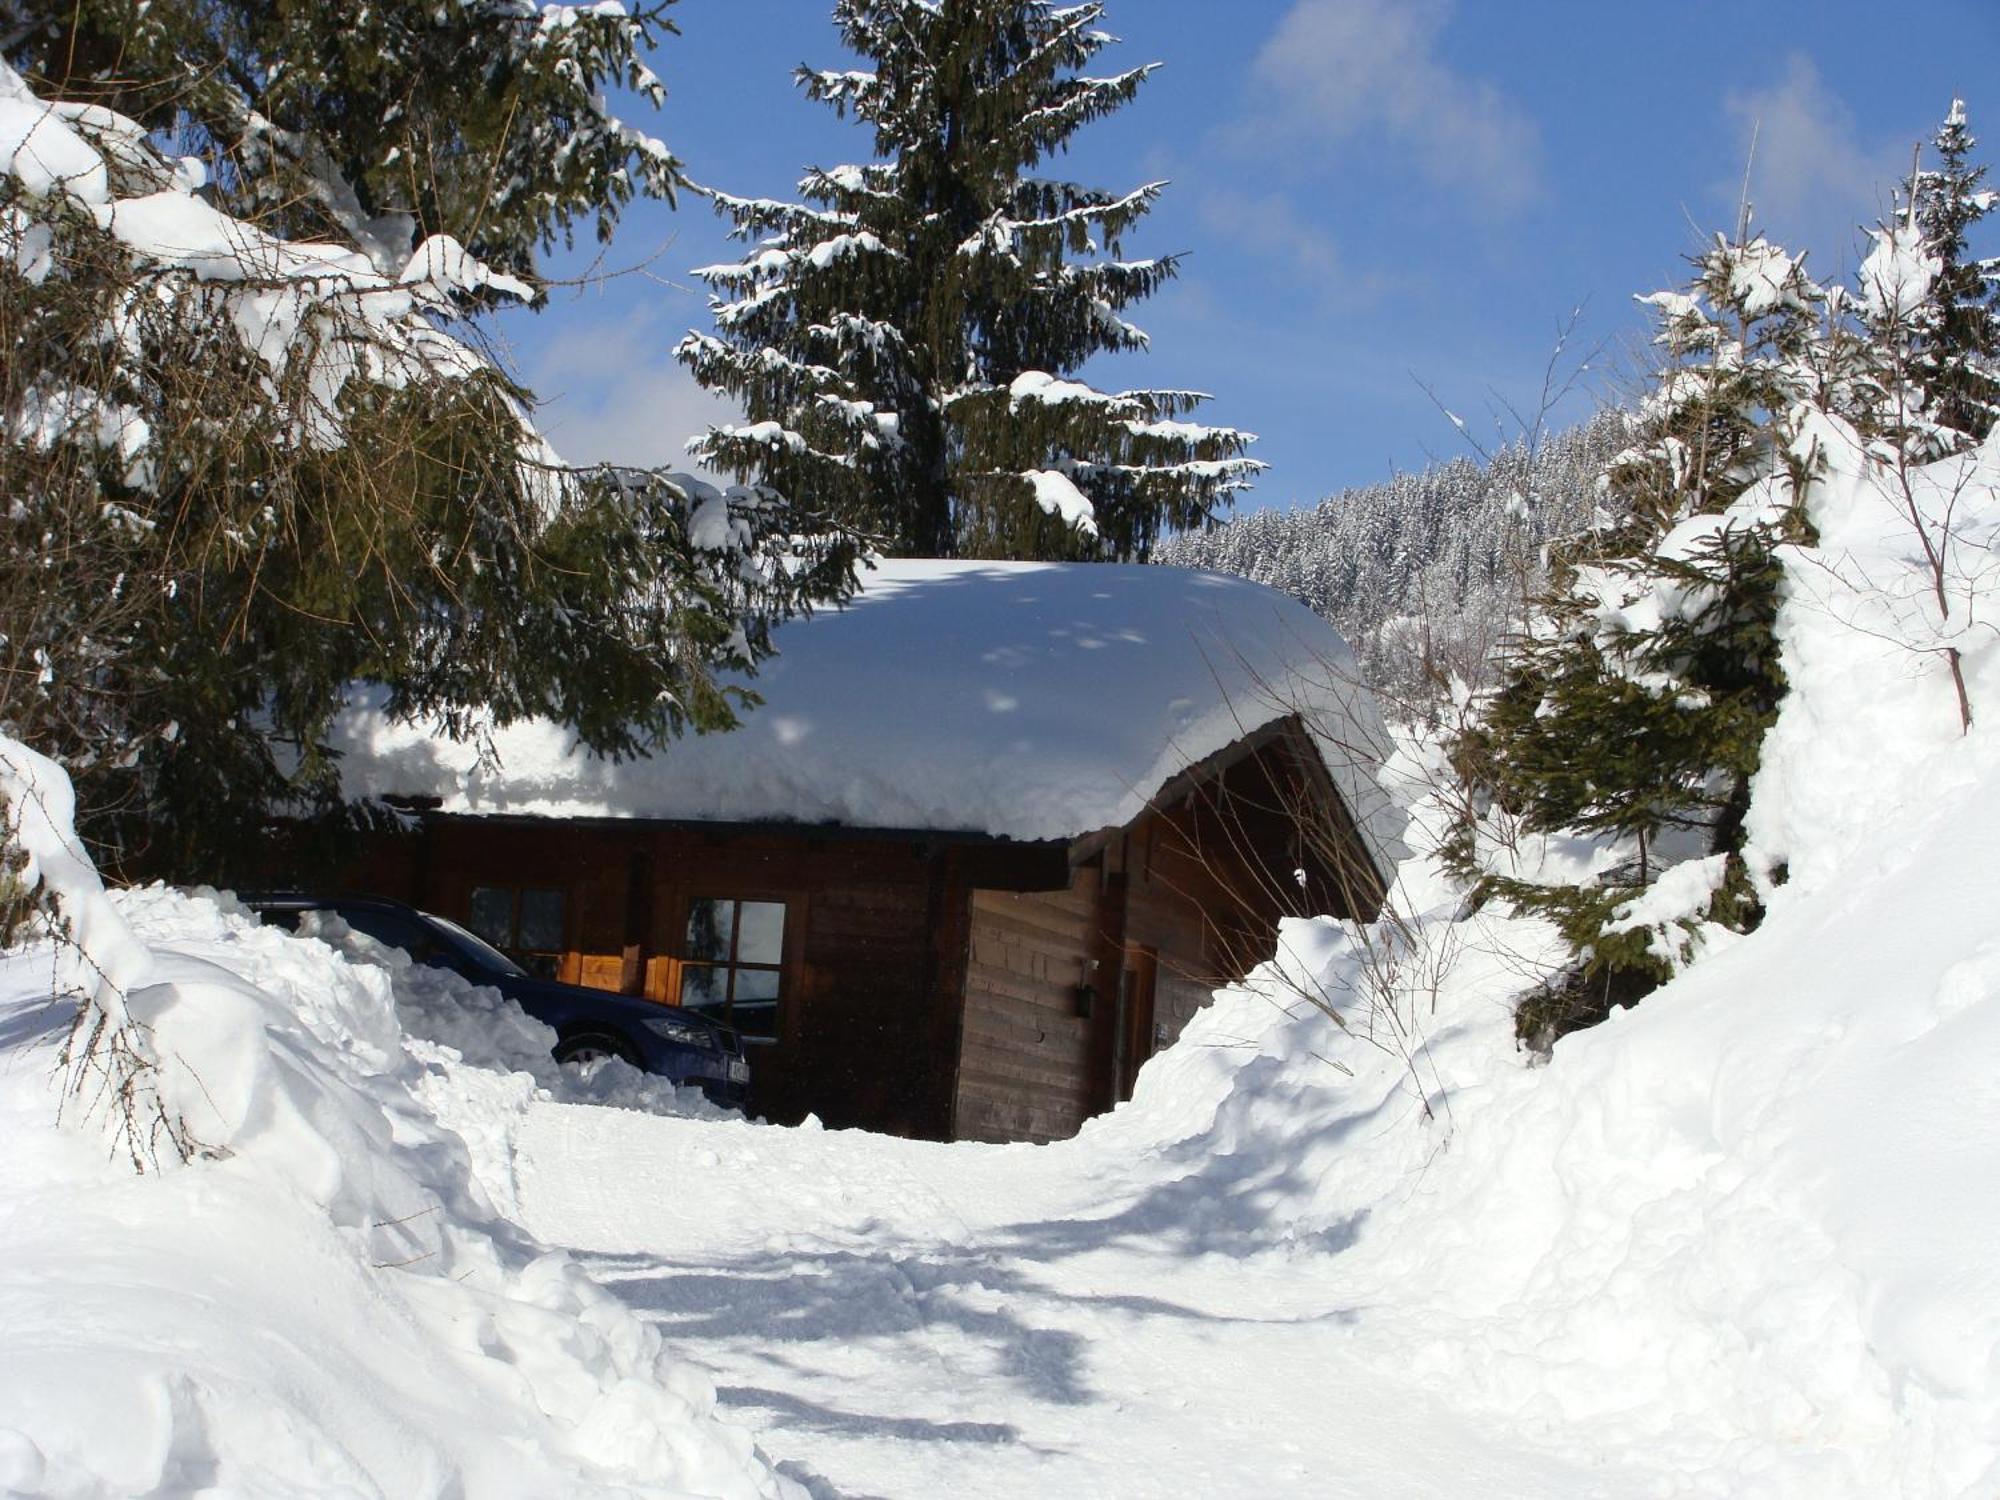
left=0, top=868, right=802, bottom=1500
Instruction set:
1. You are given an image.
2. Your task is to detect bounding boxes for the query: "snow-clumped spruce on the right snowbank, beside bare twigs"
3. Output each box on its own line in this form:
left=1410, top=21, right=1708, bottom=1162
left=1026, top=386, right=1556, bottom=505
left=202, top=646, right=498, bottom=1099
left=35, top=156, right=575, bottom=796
left=1450, top=238, right=1824, bottom=1030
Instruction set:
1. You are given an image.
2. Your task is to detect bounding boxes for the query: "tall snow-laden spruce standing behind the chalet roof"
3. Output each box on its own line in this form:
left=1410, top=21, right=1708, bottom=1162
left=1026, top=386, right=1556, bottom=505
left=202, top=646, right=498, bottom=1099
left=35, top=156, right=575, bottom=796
left=678, top=0, right=1260, bottom=558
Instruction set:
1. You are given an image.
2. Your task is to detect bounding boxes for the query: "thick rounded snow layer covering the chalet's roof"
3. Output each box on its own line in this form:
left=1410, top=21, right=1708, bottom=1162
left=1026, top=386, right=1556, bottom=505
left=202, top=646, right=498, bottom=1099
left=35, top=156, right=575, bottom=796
left=336, top=562, right=1396, bottom=856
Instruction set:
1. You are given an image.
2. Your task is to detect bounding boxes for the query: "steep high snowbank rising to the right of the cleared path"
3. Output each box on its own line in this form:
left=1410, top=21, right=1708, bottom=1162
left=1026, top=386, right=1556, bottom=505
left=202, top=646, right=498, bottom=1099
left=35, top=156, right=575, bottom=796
left=1078, top=420, right=2000, bottom=1500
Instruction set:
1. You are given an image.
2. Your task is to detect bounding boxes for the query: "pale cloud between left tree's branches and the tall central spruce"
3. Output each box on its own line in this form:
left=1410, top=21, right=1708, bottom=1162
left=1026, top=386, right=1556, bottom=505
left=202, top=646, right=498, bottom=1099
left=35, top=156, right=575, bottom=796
left=522, top=314, right=742, bottom=478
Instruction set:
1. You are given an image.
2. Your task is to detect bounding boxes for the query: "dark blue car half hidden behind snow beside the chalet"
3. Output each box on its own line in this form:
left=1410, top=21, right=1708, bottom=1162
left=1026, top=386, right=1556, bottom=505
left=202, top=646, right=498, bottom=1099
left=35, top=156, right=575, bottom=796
left=240, top=892, right=750, bottom=1108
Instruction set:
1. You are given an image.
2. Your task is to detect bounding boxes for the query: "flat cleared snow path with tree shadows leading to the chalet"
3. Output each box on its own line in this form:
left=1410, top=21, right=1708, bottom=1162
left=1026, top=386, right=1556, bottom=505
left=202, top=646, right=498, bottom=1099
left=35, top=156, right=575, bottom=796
left=516, top=1104, right=1662, bottom=1500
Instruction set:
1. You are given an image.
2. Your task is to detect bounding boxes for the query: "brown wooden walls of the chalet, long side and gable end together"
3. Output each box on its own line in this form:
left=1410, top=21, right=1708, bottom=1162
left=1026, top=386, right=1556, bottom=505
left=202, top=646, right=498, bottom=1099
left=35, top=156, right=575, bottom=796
left=332, top=726, right=1380, bottom=1140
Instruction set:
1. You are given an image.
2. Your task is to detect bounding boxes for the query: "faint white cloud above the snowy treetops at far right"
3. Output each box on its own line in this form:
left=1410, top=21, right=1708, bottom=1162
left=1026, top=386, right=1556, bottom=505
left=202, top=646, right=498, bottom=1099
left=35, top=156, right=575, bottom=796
left=1718, top=54, right=1910, bottom=278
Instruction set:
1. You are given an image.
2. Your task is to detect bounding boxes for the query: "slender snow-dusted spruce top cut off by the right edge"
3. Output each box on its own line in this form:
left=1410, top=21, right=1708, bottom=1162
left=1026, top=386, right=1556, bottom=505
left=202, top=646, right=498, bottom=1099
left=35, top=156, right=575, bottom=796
left=1904, top=98, right=2000, bottom=446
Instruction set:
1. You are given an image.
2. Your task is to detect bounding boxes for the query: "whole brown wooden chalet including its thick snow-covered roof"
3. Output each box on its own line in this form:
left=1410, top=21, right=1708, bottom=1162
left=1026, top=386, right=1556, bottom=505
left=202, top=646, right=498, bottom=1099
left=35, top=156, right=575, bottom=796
left=328, top=562, right=1394, bottom=1140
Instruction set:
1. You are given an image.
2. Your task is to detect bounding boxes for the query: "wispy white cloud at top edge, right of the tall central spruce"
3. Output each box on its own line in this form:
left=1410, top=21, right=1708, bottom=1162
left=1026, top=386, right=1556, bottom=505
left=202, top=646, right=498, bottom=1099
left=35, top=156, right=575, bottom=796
left=1252, top=0, right=1540, bottom=210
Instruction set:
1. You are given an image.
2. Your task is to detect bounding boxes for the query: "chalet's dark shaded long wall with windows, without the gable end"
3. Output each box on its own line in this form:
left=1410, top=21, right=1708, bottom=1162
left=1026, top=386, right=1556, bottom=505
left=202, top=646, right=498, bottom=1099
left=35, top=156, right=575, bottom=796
left=348, top=818, right=966, bottom=1138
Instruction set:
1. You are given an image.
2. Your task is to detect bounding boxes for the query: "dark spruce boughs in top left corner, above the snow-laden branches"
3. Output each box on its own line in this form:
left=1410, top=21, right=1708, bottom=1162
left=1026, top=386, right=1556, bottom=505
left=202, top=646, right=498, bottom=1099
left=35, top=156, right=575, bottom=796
left=0, top=0, right=682, bottom=282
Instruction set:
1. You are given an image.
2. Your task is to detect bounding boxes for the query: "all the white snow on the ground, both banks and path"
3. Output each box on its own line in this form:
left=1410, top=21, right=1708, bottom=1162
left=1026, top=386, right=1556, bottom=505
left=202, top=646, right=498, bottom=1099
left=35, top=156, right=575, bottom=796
left=0, top=434, right=2000, bottom=1500
